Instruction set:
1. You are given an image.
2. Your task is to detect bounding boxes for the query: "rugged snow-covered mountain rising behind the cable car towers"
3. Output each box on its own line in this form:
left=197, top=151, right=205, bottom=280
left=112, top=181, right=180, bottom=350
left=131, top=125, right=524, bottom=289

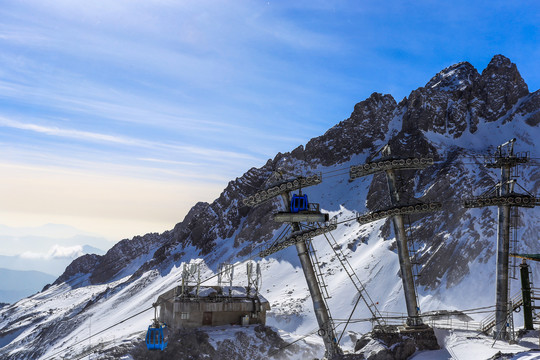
left=0, top=55, right=540, bottom=359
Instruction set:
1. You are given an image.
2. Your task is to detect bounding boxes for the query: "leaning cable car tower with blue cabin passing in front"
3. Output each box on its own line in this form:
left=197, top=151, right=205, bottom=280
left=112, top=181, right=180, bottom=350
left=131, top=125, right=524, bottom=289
left=244, top=175, right=342, bottom=359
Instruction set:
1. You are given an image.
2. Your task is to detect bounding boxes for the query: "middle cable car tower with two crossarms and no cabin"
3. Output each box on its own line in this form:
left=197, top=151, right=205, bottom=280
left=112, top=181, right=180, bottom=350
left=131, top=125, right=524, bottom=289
left=350, top=145, right=442, bottom=327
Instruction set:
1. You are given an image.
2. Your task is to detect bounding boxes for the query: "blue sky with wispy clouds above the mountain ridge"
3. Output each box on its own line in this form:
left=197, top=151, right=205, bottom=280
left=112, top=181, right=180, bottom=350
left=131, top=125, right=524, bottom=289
left=0, top=0, right=540, bottom=255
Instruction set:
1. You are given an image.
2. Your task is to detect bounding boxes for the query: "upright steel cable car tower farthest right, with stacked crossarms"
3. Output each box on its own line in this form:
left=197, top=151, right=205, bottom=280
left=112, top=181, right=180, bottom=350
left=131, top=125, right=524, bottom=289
left=463, top=139, right=540, bottom=339
